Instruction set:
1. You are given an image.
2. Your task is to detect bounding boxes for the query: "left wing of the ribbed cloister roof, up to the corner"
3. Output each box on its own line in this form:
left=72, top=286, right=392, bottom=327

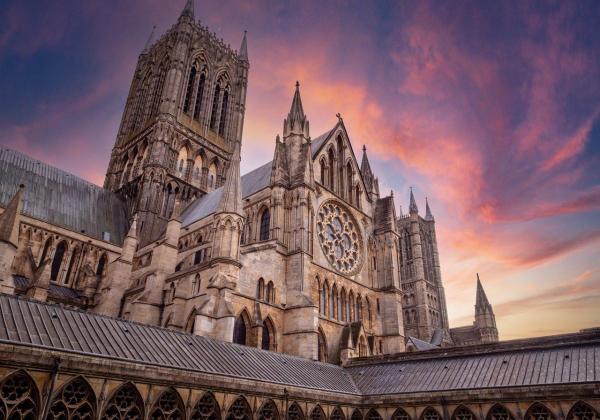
left=0, top=295, right=358, bottom=394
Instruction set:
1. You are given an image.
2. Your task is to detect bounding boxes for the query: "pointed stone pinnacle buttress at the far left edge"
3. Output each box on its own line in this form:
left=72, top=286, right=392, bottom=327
left=0, top=184, right=25, bottom=294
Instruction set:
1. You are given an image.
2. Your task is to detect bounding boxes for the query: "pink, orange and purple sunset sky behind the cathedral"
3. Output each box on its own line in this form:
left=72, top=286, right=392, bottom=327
left=0, top=0, right=600, bottom=339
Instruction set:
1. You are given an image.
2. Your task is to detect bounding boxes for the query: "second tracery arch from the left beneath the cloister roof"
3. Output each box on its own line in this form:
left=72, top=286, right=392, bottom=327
left=46, top=377, right=96, bottom=420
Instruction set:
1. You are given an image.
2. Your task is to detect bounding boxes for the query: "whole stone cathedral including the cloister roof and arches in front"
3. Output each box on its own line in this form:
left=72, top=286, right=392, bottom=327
left=0, top=0, right=600, bottom=420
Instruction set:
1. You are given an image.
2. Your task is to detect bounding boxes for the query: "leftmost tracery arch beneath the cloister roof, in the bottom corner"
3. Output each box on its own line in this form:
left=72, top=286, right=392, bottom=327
left=0, top=370, right=40, bottom=420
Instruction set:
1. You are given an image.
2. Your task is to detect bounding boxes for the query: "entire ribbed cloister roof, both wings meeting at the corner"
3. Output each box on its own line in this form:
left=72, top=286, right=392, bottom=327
left=0, top=295, right=600, bottom=395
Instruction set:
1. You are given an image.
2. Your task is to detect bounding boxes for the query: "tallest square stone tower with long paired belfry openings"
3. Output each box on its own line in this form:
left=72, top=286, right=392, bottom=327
left=104, top=0, right=249, bottom=246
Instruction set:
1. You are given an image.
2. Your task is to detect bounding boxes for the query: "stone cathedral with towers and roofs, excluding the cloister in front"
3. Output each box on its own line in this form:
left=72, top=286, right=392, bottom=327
left=0, top=2, right=498, bottom=363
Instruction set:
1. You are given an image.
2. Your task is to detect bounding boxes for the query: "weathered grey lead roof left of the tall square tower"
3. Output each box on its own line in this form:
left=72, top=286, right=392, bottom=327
left=0, top=146, right=128, bottom=245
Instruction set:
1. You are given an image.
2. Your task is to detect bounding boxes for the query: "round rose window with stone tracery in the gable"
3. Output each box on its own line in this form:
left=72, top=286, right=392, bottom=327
left=317, top=201, right=361, bottom=274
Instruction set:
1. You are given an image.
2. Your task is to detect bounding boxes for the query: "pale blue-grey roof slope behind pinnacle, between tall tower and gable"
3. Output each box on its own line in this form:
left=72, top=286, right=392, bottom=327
left=181, top=162, right=272, bottom=227
